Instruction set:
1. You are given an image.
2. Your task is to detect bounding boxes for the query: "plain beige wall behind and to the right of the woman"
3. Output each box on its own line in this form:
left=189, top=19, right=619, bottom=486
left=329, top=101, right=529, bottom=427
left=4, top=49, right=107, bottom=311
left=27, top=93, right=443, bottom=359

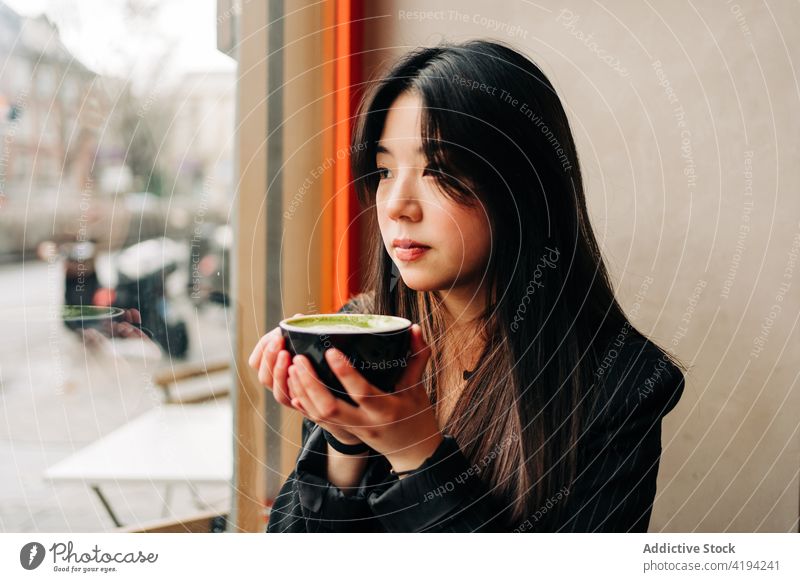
left=366, top=0, right=800, bottom=531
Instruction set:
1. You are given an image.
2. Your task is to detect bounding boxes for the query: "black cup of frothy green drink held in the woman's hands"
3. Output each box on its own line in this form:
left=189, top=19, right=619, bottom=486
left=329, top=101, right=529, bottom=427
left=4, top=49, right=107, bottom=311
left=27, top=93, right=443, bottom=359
left=279, top=313, right=411, bottom=406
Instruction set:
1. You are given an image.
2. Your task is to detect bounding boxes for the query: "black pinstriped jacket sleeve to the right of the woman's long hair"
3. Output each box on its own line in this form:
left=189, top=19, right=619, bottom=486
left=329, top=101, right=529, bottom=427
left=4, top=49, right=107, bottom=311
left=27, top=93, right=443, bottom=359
left=556, top=342, right=684, bottom=532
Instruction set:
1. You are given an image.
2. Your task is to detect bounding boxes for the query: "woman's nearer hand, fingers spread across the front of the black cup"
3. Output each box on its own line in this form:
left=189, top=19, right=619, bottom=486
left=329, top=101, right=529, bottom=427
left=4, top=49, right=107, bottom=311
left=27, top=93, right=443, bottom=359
left=289, top=324, right=443, bottom=471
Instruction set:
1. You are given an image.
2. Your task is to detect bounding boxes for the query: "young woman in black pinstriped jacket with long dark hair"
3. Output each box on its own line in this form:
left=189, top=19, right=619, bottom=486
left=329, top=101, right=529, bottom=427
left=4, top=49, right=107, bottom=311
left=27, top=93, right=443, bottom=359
left=250, top=41, right=684, bottom=532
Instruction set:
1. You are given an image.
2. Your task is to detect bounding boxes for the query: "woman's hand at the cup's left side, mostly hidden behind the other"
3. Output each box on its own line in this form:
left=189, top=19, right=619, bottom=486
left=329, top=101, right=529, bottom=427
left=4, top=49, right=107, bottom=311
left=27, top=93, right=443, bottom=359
left=247, top=313, right=361, bottom=445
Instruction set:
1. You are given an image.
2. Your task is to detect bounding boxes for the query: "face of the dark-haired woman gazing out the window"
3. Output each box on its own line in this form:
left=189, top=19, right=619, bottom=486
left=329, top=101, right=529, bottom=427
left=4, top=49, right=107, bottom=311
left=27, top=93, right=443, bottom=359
left=375, top=92, right=491, bottom=293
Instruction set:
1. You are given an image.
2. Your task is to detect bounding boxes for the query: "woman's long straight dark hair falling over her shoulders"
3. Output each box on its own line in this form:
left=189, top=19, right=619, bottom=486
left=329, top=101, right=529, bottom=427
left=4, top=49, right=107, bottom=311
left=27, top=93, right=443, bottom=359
left=351, top=40, right=680, bottom=527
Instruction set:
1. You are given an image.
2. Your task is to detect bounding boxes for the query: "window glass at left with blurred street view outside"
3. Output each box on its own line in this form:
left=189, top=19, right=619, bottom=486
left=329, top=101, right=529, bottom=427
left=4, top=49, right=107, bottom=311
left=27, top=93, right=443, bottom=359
left=0, top=0, right=235, bottom=532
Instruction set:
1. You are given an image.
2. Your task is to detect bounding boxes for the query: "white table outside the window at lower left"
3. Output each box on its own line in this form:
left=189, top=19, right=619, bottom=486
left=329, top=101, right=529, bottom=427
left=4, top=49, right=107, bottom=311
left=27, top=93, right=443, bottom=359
left=45, top=400, right=234, bottom=527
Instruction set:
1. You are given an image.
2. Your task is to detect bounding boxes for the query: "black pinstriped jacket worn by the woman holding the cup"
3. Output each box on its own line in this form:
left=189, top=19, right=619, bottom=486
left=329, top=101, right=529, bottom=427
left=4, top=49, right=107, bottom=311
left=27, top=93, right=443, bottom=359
left=267, top=308, right=684, bottom=532
